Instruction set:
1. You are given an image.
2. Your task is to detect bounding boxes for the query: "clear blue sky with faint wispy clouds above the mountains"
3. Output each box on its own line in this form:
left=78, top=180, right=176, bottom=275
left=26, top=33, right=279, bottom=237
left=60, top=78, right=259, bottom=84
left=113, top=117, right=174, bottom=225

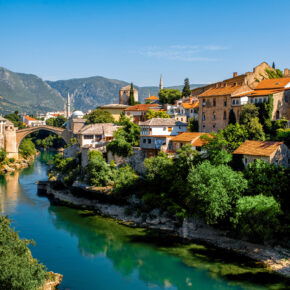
left=0, top=0, right=290, bottom=86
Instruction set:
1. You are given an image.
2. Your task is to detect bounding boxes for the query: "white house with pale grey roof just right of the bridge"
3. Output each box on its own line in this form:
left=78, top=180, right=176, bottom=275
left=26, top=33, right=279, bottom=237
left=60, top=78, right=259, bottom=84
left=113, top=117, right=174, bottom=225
left=77, top=123, right=121, bottom=149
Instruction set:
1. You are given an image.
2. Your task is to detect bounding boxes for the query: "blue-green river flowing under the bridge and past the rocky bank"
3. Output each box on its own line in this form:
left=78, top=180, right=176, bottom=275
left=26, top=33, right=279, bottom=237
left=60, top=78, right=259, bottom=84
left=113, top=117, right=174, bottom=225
left=0, top=152, right=286, bottom=290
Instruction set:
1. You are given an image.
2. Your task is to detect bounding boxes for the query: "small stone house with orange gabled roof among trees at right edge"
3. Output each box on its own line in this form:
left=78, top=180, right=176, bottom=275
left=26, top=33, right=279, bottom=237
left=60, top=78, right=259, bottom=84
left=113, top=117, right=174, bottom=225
left=233, top=140, right=288, bottom=167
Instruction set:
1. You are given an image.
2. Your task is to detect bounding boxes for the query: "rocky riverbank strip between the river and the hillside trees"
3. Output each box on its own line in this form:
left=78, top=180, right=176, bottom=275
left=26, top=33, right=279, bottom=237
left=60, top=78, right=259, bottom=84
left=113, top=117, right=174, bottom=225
left=41, top=182, right=290, bottom=278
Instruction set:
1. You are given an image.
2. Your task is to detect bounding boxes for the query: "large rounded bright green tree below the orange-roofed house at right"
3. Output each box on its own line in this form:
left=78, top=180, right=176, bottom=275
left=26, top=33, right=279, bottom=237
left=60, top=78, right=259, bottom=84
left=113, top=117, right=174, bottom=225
left=186, top=161, right=247, bottom=224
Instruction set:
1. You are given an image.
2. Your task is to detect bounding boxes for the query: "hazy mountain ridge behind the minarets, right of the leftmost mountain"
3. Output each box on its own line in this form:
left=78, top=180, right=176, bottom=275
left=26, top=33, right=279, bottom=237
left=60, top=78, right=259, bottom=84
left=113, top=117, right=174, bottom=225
left=47, top=76, right=202, bottom=111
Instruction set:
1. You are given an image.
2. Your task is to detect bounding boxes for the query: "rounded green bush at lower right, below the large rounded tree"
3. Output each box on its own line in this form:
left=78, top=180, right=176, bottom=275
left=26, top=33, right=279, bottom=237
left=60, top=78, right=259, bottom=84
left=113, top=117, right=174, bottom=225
left=233, top=195, right=282, bottom=242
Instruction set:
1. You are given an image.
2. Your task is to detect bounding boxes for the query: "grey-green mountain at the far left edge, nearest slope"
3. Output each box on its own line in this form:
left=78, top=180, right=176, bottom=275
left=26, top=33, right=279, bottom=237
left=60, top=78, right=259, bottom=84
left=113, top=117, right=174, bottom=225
left=0, top=67, right=64, bottom=113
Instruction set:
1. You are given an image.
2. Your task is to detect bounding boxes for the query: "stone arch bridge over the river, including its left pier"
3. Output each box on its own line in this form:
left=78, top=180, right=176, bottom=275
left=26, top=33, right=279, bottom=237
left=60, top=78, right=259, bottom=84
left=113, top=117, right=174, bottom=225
left=6, top=125, right=73, bottom=158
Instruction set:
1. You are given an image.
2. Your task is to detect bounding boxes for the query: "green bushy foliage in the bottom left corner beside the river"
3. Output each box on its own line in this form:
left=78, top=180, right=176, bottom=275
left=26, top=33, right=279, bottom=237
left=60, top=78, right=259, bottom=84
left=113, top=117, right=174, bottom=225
left=0, top=216, right=47, bottom=290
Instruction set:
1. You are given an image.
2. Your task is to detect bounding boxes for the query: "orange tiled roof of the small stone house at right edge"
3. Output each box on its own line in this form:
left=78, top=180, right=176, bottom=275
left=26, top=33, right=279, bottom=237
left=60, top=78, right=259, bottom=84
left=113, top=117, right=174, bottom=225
left=234, top=140, right=283, bottom=156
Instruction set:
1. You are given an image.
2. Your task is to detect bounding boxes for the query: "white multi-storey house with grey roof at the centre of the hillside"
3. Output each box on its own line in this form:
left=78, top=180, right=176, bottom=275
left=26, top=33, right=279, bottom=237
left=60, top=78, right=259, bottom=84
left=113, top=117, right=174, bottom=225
left=139, top=118, right=187, bottom=157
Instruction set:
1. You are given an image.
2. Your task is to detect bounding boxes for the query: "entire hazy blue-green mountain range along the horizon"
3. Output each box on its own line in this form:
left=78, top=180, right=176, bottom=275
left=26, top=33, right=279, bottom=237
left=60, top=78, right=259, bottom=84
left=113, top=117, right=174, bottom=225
left=0, top=67, right=202, bottom=115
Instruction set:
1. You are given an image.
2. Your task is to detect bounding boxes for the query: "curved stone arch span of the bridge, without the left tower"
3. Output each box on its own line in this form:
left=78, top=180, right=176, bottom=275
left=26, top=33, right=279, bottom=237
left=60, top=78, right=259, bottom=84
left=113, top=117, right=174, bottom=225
left=16, top=125, right=72, bottom=152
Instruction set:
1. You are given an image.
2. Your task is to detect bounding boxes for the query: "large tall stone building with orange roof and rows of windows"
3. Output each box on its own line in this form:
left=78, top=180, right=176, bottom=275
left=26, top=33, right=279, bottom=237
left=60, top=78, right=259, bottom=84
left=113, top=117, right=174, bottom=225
left=197, top=62, right=272, bottom=132
